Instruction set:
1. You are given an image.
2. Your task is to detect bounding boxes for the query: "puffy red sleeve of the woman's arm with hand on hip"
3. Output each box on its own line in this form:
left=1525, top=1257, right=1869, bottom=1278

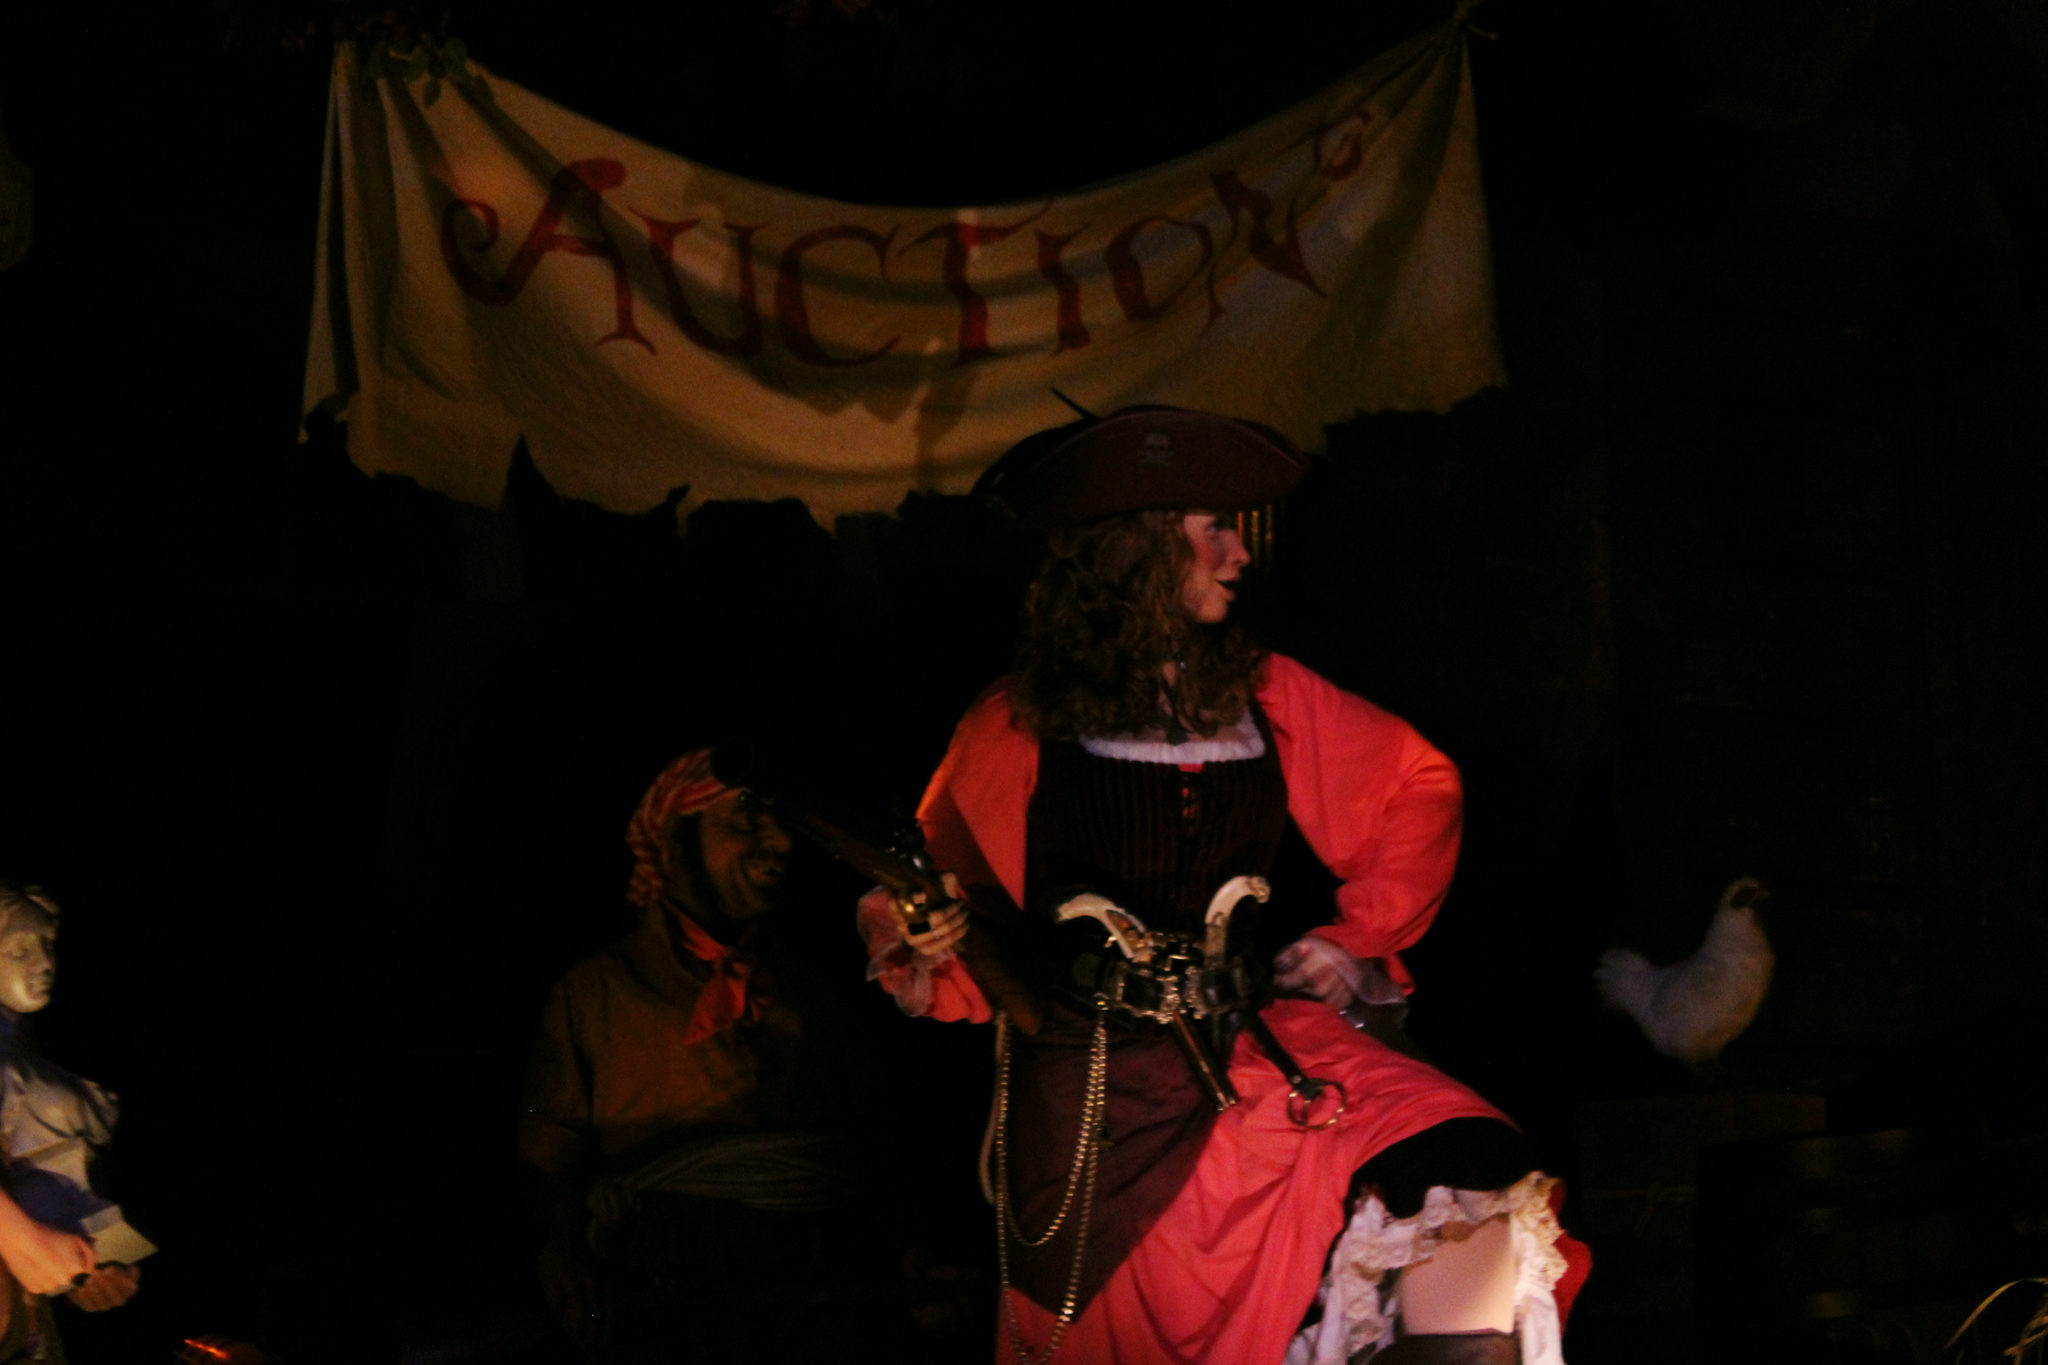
left=1260, top=655, right=1462, bottom=986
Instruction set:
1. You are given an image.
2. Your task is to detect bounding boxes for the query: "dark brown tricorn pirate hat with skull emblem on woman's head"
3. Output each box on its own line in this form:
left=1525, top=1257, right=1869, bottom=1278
left=975, top=405, right=1309, bottom=530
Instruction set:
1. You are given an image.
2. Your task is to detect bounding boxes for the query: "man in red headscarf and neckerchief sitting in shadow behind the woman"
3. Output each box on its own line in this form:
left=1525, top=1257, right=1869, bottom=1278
left=518, top=749, right=858, bottom=1361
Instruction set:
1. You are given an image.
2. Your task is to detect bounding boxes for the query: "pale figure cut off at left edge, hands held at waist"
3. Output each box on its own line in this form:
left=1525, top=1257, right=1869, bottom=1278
left=0, top=880, right=156, bottom=1365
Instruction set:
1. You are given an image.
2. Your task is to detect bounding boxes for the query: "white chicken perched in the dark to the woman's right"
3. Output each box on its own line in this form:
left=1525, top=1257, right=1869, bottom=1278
left=1593, top=876, right=1778, bottom=1066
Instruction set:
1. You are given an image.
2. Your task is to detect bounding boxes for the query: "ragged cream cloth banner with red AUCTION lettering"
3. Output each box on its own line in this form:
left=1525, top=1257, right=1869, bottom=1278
left=305, top=20, right=1503, bottom=520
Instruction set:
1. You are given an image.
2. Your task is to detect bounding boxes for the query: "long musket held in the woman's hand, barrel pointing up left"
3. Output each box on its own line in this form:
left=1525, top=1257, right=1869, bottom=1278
left=711, top=741, right=1044, bottom=1033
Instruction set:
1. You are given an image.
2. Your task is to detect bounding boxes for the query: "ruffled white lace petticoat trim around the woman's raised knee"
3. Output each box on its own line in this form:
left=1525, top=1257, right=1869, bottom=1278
left=1286, top=1171, right=1565, bottom=1365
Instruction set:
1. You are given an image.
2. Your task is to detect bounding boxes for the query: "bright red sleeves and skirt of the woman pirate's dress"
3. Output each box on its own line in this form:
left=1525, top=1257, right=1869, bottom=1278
left=868, top=655, right=1583, bottom=1365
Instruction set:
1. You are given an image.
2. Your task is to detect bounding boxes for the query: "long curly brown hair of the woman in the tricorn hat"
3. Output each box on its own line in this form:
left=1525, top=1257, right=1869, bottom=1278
left=1012, top=510, right=1266, bottom=739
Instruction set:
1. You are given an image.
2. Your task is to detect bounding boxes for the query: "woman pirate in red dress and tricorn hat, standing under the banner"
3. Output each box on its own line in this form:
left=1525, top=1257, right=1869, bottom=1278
left=862, top=407, right=1585, bottom=1365
